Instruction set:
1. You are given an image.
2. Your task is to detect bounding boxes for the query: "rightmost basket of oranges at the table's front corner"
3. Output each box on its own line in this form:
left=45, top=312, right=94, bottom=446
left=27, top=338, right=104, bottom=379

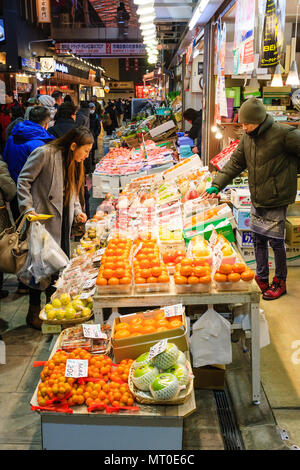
left=214, top=263, right=254, bottom=291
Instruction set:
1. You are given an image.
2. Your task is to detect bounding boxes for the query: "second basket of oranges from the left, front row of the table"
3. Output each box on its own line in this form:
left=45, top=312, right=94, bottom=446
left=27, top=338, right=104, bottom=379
left=133, top=240, right=170, bottom=293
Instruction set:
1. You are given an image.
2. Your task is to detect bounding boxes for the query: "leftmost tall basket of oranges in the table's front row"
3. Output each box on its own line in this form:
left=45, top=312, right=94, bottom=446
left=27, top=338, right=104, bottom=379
left=96, top=238, right=132, bottom=294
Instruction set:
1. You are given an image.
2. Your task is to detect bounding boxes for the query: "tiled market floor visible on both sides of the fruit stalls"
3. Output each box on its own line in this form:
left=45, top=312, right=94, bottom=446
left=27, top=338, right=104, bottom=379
left=0, top=268, right=300, bottom=450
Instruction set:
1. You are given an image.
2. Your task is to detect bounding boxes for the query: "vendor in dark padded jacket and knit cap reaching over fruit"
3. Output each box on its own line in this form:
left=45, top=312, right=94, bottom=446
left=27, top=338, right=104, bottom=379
left=203, top=98, right=300, bottom=300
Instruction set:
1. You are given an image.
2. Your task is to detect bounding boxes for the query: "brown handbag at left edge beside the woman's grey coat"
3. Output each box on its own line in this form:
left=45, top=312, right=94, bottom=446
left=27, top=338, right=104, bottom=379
left=0, top=214, right=28, bottom=274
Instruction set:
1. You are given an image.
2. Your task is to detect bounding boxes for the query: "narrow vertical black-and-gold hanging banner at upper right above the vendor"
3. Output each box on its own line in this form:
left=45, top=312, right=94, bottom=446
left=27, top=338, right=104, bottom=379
left=259, top=0, right=286, bottom=68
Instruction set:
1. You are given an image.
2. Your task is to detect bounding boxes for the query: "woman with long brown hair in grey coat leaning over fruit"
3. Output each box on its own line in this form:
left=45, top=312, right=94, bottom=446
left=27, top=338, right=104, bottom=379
left=17, top=127, right=94, bottom=329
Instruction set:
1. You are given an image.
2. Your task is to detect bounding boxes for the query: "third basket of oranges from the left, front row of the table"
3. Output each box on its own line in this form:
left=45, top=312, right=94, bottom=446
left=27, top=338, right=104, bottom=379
left=174, top=258, right=211, bottom=294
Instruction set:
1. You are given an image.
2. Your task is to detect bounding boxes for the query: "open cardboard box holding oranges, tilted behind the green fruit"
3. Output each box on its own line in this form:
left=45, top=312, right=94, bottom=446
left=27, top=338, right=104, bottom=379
left=112, top=309, right=189, bottom=363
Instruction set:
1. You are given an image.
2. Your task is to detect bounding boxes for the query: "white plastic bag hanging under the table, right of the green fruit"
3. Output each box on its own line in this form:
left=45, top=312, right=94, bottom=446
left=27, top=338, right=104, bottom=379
left=190, top=308, right=232, bottom=367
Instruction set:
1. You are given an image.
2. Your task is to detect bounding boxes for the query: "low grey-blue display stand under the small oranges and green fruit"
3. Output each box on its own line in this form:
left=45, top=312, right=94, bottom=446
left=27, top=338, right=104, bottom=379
left=30, top=341, right=196, bottom=450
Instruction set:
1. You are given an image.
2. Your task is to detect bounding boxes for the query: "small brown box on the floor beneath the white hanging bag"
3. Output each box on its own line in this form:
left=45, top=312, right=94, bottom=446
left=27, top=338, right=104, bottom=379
left=193, top=364, right=226, bottom=390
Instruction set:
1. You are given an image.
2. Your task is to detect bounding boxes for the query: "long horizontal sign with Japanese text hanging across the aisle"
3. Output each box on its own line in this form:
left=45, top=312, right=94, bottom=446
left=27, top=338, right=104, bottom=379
left=55, top=42, right=145, bottom=57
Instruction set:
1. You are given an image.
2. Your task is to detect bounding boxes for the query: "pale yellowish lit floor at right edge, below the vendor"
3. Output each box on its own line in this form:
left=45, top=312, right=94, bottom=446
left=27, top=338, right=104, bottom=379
left=261, top=267, right=300, bottom=447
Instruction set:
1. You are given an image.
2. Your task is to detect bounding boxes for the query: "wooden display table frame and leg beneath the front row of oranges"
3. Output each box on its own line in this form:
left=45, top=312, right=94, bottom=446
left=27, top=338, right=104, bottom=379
left=94, top=280, right=260, bottom=404
